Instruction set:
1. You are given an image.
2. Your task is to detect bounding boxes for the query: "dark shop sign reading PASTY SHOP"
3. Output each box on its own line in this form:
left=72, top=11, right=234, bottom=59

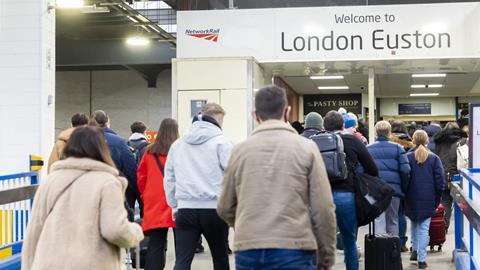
left=303, top=94, right=362, bottom=116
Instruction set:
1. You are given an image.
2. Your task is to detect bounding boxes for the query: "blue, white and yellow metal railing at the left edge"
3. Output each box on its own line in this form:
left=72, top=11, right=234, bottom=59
left=0, top=172, right=38, bottom=270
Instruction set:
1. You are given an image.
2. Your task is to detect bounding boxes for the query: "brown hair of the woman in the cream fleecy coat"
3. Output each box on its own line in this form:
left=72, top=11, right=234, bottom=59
left=63, top=126, right=115, bottom=168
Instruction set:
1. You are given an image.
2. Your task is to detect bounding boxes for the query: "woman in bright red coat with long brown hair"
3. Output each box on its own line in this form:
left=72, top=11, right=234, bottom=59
left=137, top=118, right=179, bottom=270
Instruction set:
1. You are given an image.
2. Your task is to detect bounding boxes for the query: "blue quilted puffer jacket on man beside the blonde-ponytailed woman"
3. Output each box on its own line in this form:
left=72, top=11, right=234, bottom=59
left=367, top=137, right=410, bottom=197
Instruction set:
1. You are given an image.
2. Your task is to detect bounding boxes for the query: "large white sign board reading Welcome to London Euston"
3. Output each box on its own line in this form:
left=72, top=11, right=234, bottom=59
left=177, top=3, right=480, bottom=62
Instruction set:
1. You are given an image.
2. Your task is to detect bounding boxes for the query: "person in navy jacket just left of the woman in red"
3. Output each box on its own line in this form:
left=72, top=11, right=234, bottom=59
left=92, top=110, right=141, bottom=210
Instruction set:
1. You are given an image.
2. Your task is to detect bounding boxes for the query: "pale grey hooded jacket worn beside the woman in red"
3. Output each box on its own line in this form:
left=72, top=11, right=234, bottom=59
left=164, top=121, right=233, bottom=210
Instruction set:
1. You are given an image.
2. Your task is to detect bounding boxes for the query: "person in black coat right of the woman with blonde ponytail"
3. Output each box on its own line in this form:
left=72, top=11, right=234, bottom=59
left=433, top=122, right=468, bottom=232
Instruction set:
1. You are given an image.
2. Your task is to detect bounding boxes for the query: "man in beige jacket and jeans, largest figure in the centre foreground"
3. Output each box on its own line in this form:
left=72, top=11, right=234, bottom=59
left=217, top=86, right=336, bottom=270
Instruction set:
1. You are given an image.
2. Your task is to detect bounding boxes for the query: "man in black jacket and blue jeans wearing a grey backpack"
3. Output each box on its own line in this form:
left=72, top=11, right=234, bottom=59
left=323, top=111, right=378, bottom=270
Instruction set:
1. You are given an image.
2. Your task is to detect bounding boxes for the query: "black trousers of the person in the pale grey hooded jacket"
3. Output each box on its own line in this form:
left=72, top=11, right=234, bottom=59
left=174, top=209, right=230, bottom=270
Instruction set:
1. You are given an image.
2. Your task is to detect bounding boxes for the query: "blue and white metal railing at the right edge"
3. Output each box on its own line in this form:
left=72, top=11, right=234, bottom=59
left=451, top=169, right=480, bottom=270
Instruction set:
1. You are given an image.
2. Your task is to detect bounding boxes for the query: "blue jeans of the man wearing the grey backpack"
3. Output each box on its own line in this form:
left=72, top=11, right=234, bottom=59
left=333, top=192, right=358, bottom=270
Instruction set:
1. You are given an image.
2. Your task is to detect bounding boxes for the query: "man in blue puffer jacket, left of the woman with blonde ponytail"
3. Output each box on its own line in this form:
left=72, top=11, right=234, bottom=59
left=367, top=121, right=410, bottom=236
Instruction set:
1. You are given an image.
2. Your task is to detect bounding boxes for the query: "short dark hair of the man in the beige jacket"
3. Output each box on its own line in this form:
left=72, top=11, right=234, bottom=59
left=255, top=85, right=287, bottom=121
